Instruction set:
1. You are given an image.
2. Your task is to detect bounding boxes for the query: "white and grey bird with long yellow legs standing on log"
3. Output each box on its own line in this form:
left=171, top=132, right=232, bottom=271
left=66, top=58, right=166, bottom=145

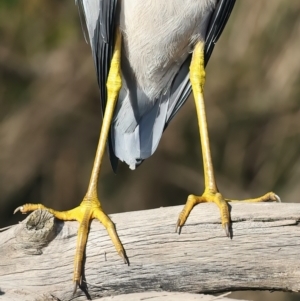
left=15, top=0, right=279, bottom=292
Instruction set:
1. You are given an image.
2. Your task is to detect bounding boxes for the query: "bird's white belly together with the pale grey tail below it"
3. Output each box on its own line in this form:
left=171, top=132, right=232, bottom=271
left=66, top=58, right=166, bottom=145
left=111, top=0, right=217, bottom=169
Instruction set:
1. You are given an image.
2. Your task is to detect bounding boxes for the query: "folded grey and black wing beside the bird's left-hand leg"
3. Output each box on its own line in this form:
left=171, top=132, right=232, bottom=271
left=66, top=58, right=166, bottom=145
left=75, top=0, right=118, bottom=171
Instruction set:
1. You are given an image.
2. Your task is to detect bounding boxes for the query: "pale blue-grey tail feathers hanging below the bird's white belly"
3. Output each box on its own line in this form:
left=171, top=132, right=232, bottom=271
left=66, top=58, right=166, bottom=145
left=111, top=64, right=168, bottom=169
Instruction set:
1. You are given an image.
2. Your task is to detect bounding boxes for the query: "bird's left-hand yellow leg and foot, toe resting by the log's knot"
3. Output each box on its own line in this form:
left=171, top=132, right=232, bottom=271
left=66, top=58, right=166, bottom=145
left=15, top=29, right=128, bottom=292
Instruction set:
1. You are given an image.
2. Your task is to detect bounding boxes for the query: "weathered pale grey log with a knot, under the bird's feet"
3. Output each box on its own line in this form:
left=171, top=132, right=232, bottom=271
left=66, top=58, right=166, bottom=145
left=0, top=203, right=300, bottom=300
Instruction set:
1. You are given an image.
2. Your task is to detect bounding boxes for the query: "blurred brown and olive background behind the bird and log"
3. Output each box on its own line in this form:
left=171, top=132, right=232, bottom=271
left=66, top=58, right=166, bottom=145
left=0, top=0, right=300, bottom=300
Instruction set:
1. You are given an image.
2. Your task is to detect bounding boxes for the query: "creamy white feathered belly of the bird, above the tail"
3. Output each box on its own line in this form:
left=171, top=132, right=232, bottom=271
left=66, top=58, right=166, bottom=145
left=120, top=0, right=217, bottom=101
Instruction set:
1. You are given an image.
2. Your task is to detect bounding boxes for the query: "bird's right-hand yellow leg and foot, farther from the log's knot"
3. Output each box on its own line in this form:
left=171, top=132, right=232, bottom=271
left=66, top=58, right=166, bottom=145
left=176, top=42, right=280, bottom=237
